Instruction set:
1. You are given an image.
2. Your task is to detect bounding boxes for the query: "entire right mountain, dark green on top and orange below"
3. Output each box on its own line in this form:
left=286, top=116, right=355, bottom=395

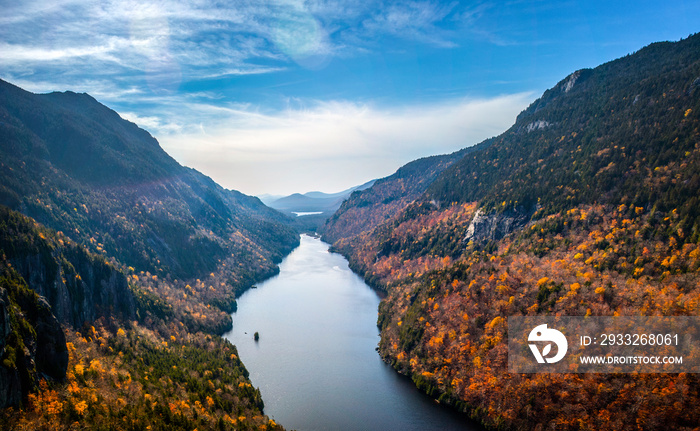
left=325, top=35, right=700, bottom=430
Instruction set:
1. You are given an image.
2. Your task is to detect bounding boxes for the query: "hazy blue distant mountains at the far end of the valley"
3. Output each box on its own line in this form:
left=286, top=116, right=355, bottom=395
left=260, top=180, right=374, bottom=216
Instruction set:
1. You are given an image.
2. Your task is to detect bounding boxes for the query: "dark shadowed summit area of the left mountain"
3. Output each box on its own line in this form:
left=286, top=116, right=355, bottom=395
left=0, top=82, right=180, bottom=186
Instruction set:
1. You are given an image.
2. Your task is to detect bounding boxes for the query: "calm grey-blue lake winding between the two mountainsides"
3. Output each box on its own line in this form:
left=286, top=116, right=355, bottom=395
left=225, top=235, right=480, bottom=431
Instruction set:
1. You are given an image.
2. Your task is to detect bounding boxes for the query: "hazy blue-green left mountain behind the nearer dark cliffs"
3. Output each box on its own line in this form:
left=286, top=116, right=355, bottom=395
left=0, top=77, right=298, bottom=284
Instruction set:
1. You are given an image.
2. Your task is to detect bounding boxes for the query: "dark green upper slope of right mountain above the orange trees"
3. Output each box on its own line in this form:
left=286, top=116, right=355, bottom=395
left=427, top=36, right=700, bottom=230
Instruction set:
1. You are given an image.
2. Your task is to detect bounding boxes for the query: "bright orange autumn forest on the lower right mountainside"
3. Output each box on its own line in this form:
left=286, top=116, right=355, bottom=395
left=330, top=204, right=700, bottom=430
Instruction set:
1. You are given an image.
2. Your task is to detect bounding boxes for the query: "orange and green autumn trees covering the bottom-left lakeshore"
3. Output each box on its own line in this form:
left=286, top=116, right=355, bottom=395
left=0, top=321, right=281, bottom=431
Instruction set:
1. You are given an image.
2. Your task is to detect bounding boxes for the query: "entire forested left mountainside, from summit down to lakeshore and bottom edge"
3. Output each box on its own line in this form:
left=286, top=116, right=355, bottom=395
left=0, top=81, right=299, bottom=430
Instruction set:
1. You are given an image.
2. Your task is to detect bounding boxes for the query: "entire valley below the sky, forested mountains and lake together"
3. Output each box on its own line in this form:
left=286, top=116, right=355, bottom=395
left=0, top=21, right=700, bottom=431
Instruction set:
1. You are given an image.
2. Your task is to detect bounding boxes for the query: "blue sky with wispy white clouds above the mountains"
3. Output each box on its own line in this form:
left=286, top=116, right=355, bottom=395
left=0, top=0, right=700, bottom=195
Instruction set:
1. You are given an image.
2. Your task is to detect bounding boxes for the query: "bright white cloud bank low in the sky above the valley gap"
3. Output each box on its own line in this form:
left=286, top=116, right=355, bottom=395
left=157, top=93, right=532, bottom=194
